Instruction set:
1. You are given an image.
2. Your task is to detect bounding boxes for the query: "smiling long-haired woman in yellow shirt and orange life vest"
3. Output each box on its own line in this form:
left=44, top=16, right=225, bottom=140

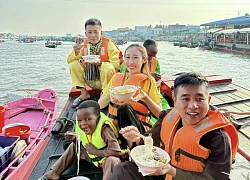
left=99, top=44, right=161, bottom=146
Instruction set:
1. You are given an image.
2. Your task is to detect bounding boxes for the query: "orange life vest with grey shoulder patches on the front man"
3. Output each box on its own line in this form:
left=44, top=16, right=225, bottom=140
left=161, top=109, right=238, bottom=180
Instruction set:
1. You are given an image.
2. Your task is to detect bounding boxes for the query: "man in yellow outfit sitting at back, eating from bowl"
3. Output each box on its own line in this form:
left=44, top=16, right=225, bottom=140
left=67, top=19, right=123, bottom=107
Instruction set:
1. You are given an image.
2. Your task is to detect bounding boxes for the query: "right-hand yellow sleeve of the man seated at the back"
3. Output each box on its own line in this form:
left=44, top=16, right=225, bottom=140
left=108, top=40, right=120, bottom=71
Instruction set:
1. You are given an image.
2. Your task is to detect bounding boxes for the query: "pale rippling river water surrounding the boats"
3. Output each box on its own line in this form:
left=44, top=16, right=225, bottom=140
left=0, top=41, right=250, bottom=179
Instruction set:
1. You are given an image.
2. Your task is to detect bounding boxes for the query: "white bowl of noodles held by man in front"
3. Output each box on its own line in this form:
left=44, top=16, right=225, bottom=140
left=130, top=145, right=170, bottom=172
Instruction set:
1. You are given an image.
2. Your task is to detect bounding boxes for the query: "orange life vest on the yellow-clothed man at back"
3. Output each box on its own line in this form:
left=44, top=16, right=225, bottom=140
left=83, top=37, right=123, bottom=64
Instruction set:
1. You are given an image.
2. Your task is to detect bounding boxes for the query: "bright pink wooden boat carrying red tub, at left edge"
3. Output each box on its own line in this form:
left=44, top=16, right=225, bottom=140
left=0, top=89, right=58, bottom=180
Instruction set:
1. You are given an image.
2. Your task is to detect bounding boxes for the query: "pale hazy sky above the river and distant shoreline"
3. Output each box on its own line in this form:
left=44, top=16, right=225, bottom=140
left=0, top=0, right=250, bottom=36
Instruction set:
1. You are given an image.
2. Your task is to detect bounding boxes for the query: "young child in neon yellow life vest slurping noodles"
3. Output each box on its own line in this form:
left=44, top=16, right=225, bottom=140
left=40, top=100, right=122, bottom=180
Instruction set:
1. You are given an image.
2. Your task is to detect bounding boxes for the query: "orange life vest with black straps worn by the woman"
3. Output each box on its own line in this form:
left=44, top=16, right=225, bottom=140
left=108, top=73, right=151, bottom=130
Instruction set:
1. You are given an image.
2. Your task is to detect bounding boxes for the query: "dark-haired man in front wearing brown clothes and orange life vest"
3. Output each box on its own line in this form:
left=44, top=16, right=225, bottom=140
left=112, top=73, right=238, bottom=180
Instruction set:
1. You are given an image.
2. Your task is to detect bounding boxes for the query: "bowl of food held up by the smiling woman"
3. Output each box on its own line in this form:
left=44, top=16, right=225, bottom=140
left=111, top=85, right=138, bottom=101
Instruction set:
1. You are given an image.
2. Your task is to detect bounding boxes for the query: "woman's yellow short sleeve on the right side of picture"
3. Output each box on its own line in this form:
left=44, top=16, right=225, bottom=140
left=142, top=78, right=161, bottom=104
